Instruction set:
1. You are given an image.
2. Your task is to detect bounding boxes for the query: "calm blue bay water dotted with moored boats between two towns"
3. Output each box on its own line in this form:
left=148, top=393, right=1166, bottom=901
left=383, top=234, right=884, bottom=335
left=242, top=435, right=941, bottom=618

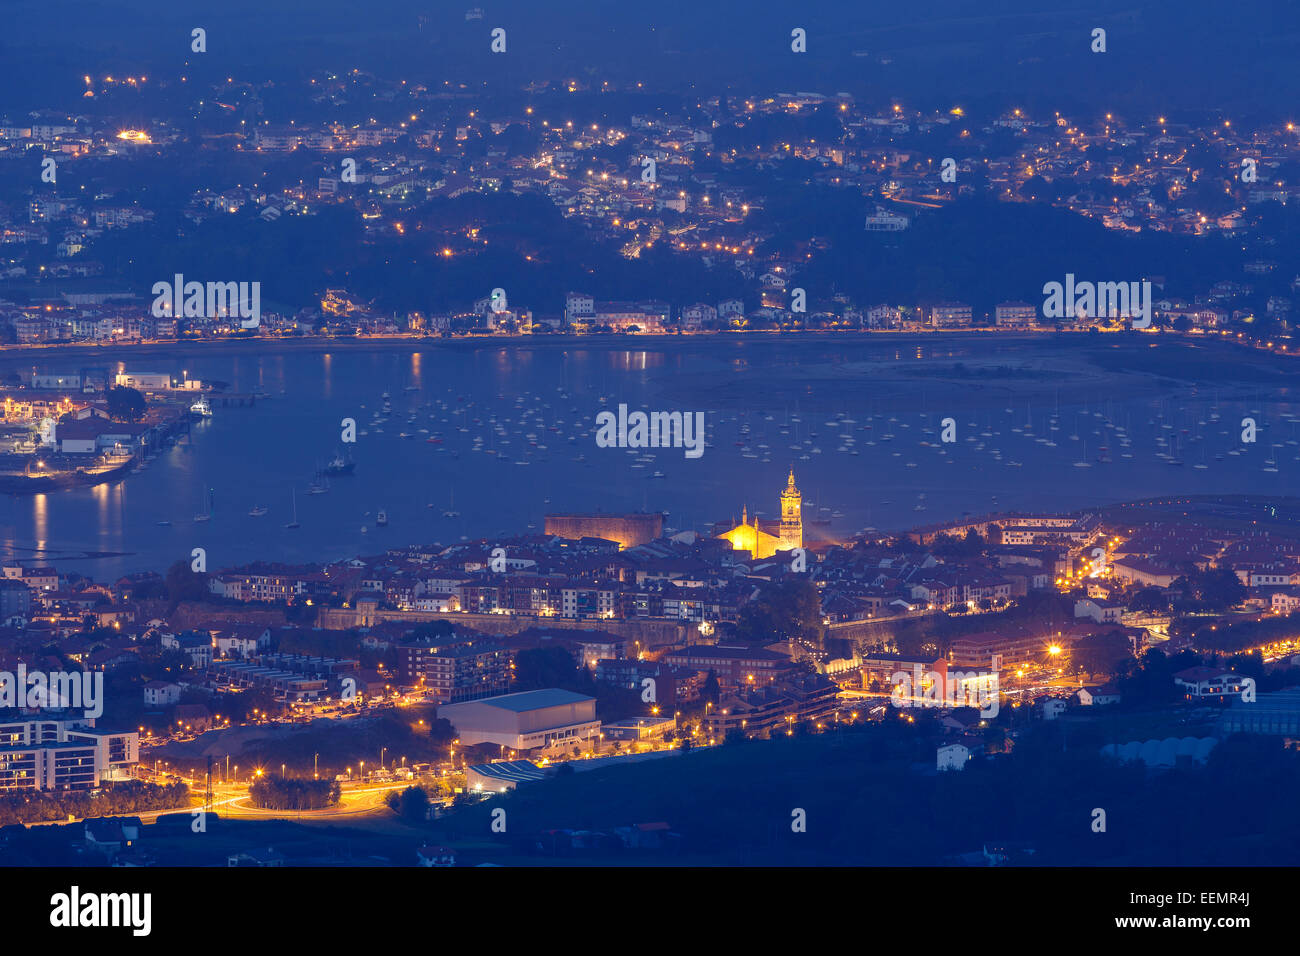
left=0, top=339, right=1300, bottom=579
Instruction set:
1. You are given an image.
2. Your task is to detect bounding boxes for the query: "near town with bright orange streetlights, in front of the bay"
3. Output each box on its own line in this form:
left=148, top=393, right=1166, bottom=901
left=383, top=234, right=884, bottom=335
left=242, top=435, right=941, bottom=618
left=0, top=483, right=1300, bottom=827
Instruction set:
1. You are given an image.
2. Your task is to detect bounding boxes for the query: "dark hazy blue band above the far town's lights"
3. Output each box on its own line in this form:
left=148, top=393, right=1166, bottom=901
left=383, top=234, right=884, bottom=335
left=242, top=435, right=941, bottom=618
left=0, top=0, right=1300, bottom=118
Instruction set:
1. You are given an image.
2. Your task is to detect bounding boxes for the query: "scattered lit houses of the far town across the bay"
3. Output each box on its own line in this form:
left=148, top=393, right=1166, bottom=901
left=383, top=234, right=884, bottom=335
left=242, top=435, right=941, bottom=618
left=0, top=81, right=1300, bottom=351
